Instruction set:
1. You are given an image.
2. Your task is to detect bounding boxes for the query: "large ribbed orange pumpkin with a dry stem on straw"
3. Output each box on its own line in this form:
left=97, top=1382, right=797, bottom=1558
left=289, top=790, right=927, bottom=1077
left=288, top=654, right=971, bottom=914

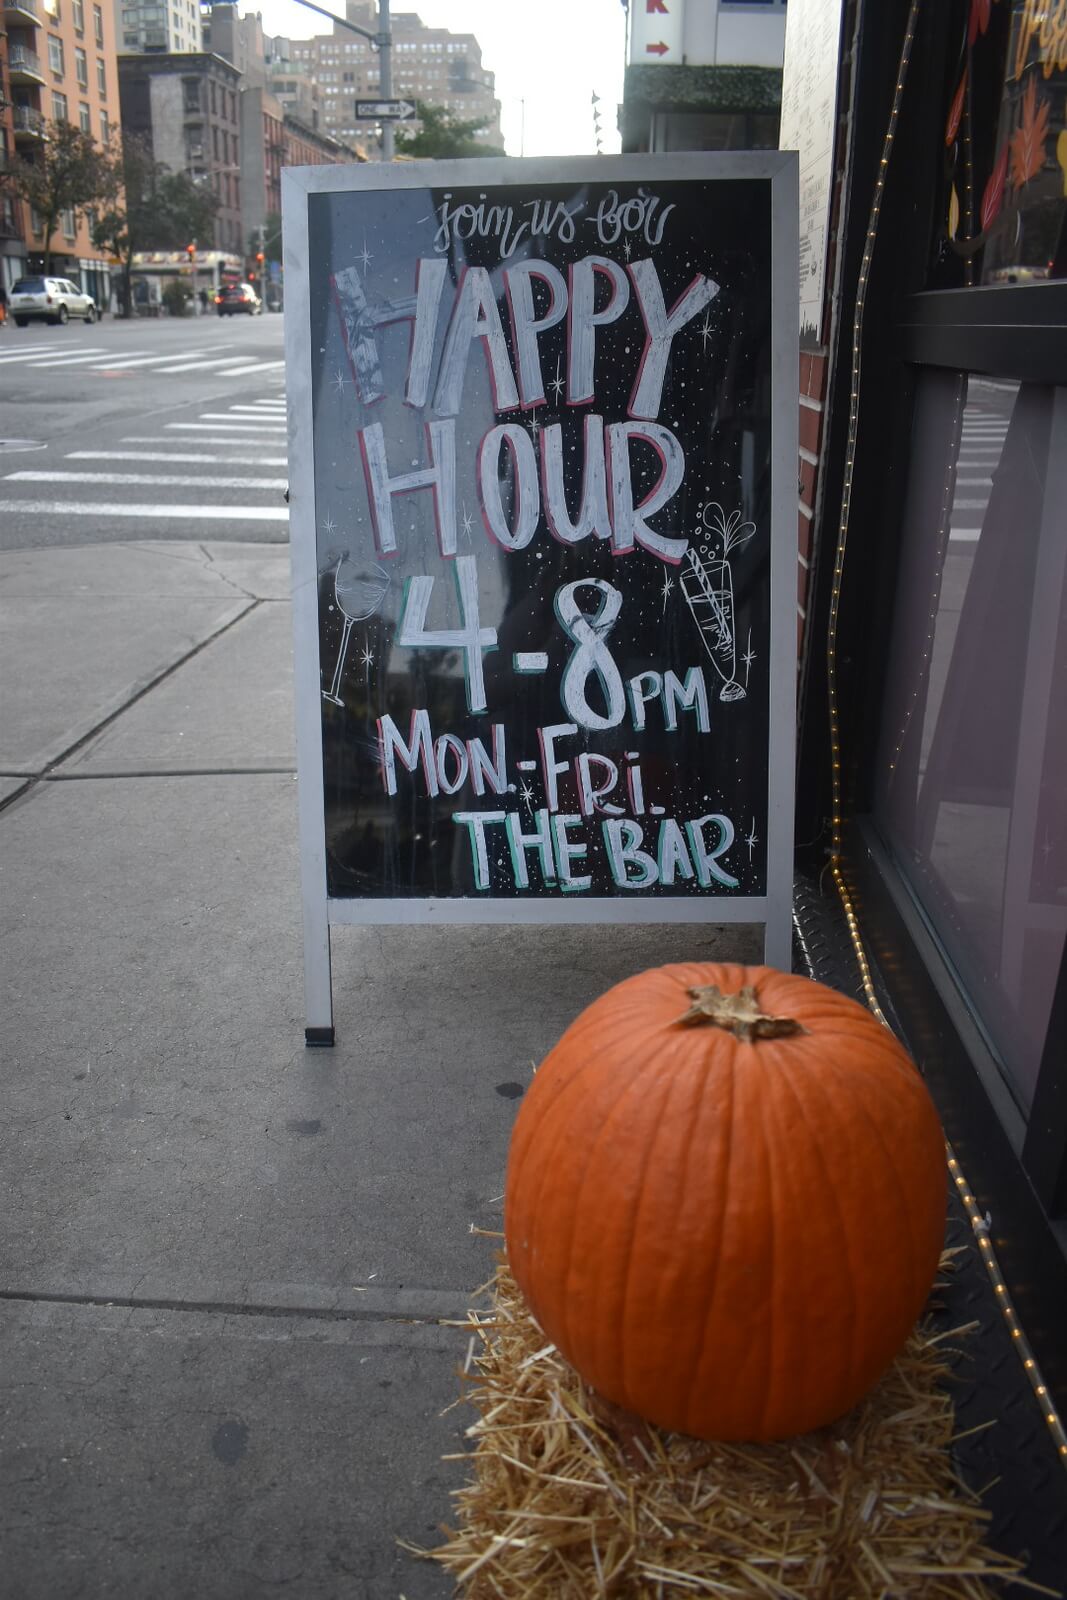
left=504, top=965, right=945, bottom=1440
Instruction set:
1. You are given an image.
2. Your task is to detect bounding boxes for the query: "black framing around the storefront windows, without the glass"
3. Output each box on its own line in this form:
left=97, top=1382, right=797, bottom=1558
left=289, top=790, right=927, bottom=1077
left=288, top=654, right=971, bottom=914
left=797, top=0, right=1067, bottom=1405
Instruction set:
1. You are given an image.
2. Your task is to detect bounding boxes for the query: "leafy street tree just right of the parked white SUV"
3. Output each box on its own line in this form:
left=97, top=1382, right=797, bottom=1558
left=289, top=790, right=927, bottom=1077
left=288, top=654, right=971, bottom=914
left=93, top=133, right=219, bottom=317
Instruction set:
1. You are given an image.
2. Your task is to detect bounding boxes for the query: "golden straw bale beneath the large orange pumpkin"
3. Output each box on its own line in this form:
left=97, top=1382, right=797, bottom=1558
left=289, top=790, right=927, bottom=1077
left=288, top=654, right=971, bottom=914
left=406, top=1256, right=1051, bottom=1600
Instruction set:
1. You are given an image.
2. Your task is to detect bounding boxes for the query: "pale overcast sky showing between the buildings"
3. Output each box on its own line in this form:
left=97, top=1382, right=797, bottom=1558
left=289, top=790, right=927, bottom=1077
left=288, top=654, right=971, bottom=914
left=240, top=0, right=625, bottom=155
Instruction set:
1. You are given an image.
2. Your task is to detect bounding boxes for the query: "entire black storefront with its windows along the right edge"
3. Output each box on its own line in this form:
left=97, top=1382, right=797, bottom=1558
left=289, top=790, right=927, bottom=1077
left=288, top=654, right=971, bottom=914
left=798, top=0, right=1067, bottom=1452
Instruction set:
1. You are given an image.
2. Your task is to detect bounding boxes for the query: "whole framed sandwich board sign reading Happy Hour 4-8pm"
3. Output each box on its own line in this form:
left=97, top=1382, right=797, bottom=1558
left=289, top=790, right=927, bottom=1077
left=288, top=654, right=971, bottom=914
left=282, top=150, right=797, bottom=1043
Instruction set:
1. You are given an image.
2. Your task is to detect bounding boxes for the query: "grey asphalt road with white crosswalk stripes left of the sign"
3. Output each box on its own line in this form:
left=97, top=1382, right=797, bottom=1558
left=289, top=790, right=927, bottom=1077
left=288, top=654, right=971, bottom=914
left=0, top=312, right=288, bottom=550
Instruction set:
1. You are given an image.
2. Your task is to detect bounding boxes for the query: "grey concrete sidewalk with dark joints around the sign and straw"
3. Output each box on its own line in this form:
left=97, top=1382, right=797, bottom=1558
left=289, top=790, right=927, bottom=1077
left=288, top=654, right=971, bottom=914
left=0, top=542, right=758, bottom=1600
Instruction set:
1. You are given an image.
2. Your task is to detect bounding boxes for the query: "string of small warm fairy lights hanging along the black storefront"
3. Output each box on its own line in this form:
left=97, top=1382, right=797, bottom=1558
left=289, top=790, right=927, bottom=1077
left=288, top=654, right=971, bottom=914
left=827, top=0, right=1067, bottom=1467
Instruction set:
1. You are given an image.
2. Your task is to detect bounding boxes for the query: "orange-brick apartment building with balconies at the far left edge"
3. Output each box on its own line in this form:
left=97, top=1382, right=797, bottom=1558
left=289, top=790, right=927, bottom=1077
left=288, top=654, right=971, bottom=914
left=0, top=0, right=118, bottom=307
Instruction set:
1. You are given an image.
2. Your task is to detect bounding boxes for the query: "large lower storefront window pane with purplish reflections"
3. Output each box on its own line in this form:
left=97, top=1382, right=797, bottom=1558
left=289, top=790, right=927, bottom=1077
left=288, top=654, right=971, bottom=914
left=875, top=370, right=1067, bottom=1110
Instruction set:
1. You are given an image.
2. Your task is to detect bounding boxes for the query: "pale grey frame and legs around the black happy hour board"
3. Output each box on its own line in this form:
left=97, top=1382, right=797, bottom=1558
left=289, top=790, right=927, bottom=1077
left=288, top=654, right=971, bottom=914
left=282, top=150, right=798, bottom=1043
